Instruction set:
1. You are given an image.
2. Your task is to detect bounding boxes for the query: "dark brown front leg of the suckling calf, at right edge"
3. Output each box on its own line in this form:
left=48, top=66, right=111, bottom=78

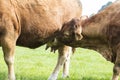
left=112, top=46, right=120, bottom=80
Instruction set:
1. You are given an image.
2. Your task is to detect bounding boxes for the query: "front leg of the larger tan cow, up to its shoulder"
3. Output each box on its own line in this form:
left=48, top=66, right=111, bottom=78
left=0, top=12, right=20, bottom=80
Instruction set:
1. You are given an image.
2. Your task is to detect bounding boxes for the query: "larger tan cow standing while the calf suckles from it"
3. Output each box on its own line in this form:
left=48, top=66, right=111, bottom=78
left=0, top=0, right=82, bottom=80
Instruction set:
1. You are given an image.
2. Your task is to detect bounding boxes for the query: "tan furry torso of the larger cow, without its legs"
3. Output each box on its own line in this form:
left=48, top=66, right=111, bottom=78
left=0, top=0, right=81, bottom=48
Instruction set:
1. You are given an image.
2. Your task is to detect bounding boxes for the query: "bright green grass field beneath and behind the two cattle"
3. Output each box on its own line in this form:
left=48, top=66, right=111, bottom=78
left=0, top=46, right=113, bottom=80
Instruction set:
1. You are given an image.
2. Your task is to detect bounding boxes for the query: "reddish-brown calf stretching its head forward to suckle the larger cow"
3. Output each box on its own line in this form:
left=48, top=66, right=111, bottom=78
left=49, top=0, right=120, bottom=80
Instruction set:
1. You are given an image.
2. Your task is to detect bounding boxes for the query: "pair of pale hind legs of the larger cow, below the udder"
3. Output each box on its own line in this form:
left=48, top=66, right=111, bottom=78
left=48, top=46, right=72, bottom=80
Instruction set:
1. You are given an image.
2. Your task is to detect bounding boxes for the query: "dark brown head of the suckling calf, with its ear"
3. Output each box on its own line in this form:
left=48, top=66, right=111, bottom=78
left=57, top=19, right=82, bottom=45
